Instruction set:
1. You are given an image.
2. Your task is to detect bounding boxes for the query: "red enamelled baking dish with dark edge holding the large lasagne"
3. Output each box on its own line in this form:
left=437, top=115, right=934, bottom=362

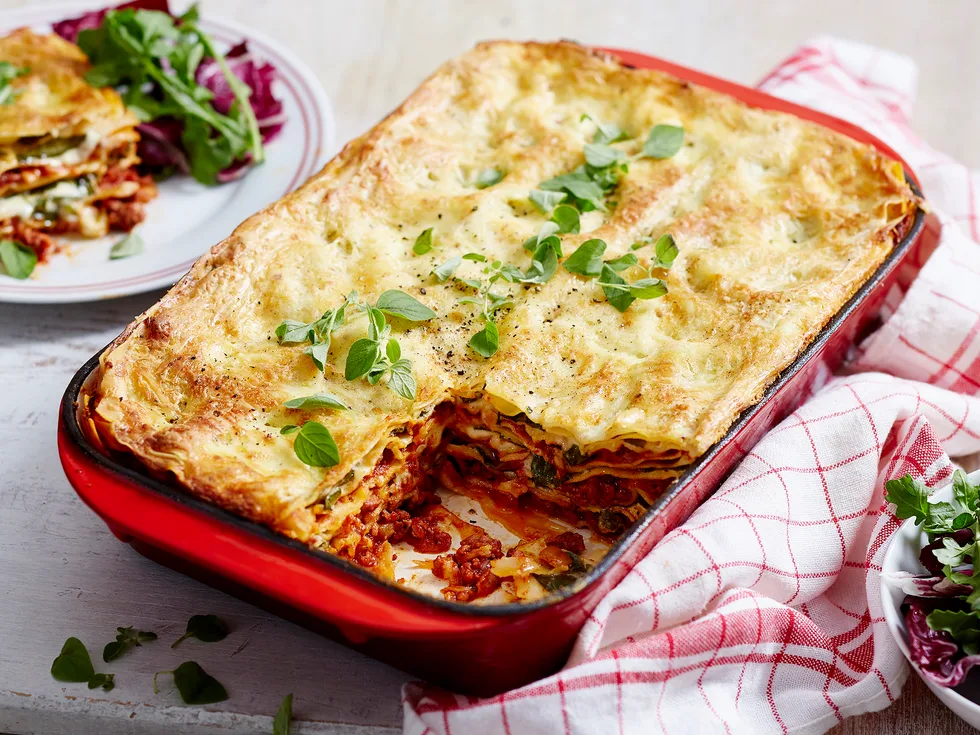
left=58, top=50, right=924, bottom=695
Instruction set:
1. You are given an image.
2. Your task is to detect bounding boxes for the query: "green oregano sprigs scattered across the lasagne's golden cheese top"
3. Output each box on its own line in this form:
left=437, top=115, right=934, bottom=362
left=262, top=114, right=685, bottom=467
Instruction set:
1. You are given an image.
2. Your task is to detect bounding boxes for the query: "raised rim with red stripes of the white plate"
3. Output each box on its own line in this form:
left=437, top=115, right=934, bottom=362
left=0, top=2, right=336, bottom=304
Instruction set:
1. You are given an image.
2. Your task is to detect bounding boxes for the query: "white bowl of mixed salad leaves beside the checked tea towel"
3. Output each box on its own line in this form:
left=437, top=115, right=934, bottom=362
left=881, top=470, right=980, bottom=729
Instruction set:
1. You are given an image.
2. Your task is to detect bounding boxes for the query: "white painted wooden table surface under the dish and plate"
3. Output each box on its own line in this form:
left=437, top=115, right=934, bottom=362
left=0, top=0, right=980, bottom=735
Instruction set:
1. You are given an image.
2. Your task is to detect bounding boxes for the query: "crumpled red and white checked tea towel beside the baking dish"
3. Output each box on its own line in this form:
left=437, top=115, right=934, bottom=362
left=404, top=39, right=980, bottom=735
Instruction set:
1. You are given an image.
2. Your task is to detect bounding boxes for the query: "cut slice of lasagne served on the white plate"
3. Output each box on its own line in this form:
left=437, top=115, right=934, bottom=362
left=0, top=28, right=156, bottom=264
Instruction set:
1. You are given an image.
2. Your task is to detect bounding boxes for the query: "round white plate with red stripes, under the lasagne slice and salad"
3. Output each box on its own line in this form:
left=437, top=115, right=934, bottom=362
left=0, top=0, right=335, bottom=304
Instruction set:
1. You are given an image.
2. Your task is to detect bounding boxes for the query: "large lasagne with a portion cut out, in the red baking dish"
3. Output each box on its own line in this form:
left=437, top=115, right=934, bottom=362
left=82, top=42, right=917, bottom=601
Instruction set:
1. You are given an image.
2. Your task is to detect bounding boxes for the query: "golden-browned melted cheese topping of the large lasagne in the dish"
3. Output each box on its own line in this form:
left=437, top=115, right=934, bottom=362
left=93, top=42, right=915, bottom=539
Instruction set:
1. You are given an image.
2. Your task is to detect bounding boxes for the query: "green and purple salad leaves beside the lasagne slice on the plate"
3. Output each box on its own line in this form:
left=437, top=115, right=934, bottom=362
left=54, top=0, right=284, bottom=184
